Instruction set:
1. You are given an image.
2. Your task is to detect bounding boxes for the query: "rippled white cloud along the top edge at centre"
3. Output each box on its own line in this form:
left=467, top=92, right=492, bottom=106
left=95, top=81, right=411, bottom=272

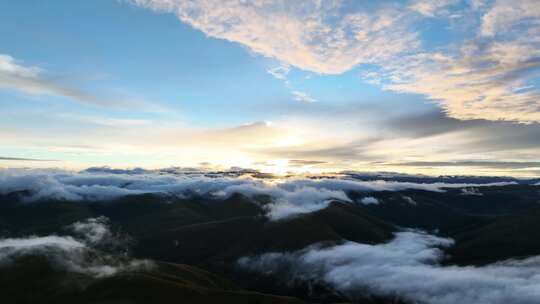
left=132, top=0, right=417, bottom=74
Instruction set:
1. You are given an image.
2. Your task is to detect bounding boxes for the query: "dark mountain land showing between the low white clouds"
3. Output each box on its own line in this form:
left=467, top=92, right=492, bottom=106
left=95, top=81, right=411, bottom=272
left=0, top=185, right=540, bottom=303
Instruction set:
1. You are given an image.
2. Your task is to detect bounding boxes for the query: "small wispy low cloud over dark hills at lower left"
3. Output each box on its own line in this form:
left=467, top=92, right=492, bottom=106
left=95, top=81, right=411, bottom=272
left=0, top=217, right=154, bottom=277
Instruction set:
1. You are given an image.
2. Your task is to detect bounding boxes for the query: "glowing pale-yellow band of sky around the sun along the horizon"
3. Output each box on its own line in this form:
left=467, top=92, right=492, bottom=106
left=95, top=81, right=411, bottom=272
left=4, top=105, right=540, bottom=176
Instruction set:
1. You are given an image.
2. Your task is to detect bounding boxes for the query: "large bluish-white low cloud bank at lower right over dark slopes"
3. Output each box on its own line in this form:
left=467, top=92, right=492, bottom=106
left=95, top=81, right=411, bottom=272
left=238, top=231, right=540, bottom=304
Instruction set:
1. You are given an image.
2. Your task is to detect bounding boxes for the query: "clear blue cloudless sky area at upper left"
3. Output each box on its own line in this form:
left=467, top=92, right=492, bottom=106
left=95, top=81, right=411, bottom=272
left=0, top=0, right=400, bottom=126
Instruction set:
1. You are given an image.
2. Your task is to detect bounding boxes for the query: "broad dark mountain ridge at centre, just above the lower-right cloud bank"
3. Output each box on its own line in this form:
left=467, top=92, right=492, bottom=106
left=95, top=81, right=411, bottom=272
left=135, top=202, right=395, bottom=265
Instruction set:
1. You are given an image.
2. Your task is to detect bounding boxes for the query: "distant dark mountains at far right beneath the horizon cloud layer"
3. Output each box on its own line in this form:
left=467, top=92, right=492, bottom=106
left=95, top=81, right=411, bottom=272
left=349, top=185, right=540, bottom=237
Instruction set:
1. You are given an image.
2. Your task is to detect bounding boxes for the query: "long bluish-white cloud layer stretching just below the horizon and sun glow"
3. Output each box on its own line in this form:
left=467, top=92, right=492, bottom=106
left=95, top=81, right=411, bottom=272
left=0, top=168, right=515, bottom=220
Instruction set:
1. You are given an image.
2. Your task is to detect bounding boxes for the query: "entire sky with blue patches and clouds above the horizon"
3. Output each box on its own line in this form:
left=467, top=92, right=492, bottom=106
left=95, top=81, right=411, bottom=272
left=0, top=0, right=540, bottom=176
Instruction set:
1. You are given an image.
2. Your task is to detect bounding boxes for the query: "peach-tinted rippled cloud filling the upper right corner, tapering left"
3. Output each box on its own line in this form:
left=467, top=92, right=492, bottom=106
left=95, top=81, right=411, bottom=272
left=367, top=0, right=540, bottom=123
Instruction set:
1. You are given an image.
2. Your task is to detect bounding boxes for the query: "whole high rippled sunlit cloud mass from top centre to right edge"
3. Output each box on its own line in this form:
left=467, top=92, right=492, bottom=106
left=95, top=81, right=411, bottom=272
left=132, top=0, right=540, bottom=123
